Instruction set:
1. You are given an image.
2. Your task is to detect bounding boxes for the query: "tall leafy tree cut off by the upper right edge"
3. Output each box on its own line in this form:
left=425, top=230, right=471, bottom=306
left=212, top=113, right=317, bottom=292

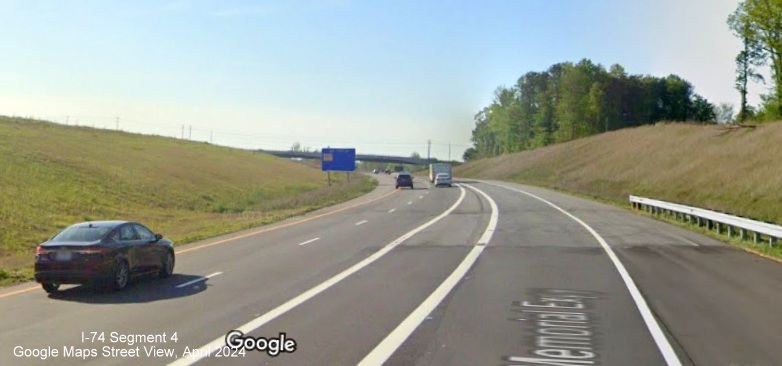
left=728, top=0, right=782, bottom=118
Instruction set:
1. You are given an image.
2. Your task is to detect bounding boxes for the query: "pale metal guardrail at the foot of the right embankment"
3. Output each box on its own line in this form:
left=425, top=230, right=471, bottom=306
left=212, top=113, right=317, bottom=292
left=630, top=196, right=782, bottom=246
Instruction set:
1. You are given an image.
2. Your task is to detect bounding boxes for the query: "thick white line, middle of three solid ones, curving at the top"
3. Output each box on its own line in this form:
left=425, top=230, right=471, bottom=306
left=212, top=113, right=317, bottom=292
left=358, top=184, right=499, bottom=366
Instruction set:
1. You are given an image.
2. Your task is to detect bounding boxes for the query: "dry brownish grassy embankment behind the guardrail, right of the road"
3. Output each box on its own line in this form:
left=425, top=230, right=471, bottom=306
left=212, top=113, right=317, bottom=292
left=454, top=123, right=782, bottom=258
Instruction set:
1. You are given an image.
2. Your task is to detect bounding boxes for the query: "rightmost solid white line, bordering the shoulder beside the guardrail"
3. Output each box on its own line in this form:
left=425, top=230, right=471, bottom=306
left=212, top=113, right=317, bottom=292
left=486, top=182, right=682, bottom=366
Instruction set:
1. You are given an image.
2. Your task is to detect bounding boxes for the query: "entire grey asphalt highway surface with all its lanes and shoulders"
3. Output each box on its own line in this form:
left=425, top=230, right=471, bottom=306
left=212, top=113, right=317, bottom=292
left=0, top=174, right=782, bottom=366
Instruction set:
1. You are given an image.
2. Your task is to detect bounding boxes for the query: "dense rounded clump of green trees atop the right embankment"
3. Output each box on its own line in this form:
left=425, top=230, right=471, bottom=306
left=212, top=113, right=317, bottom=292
left=463, top=59, right=719, bottom=161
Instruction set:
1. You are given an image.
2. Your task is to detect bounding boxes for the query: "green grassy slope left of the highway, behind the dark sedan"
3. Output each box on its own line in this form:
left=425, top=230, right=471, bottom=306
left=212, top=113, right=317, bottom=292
left=0, top=117, right=375, bottom=285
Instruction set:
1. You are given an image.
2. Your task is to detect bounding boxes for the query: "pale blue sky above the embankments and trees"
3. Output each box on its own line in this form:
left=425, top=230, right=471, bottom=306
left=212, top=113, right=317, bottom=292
left=0, top=0, right=766, bottom=160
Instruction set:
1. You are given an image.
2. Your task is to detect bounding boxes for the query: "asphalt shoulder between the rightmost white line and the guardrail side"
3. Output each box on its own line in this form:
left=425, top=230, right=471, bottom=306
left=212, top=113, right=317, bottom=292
left=460, top=182, right=782, bottom=366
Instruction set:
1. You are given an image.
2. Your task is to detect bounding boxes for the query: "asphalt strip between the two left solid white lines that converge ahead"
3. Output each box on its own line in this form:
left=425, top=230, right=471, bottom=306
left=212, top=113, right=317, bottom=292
left=193, top=182, right=488, bottom=365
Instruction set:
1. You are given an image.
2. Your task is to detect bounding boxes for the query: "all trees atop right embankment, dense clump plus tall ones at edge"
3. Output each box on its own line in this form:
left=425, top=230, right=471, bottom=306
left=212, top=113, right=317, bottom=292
left=463, top=0, right=782, bottom=161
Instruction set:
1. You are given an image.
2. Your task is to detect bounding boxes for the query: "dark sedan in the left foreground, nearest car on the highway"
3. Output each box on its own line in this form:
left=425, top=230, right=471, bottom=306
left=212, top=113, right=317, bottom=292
left=35, top=221, right=175, bottom=293
